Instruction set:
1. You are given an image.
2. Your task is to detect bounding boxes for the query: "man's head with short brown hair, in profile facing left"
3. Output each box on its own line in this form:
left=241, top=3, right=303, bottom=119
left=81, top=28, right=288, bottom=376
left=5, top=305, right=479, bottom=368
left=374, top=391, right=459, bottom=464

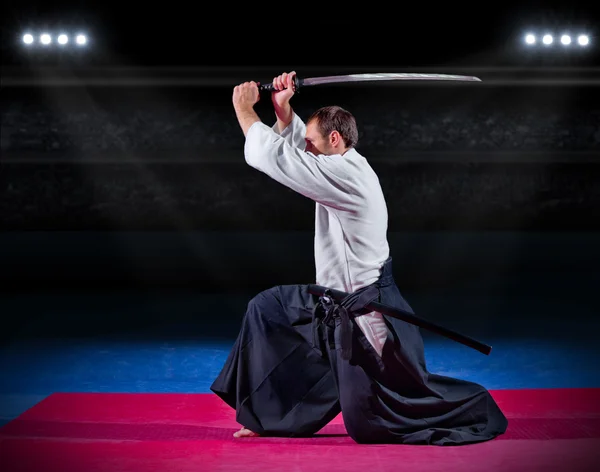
left=305, top=106, right=358, bottom=156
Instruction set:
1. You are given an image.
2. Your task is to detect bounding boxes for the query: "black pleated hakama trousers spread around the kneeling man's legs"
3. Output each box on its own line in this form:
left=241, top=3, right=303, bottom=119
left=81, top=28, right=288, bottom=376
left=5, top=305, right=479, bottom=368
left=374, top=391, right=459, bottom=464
left=211, top=258, right=508, bottom=445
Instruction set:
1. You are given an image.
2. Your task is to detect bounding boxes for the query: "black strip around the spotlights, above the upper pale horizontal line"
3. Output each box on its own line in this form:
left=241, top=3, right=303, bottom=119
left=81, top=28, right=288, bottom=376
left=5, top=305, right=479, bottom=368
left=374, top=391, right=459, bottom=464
left=1, top=0, right=599, bottom=70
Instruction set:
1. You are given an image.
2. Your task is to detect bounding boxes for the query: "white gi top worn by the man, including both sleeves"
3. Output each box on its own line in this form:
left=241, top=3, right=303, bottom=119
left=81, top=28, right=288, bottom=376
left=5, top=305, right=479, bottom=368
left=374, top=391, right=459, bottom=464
left=244, top=113, right=389, bottom=355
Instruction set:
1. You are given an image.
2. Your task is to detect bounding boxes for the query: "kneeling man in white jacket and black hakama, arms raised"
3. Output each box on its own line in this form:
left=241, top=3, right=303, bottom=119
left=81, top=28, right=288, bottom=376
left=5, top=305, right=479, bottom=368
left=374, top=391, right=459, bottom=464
left=211, top=72, right=507, bottom=445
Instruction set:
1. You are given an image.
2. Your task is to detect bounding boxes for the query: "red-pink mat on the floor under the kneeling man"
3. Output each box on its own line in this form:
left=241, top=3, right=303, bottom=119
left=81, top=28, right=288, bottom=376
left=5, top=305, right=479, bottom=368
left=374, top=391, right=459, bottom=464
left=0, top=389, right=600, bottom=472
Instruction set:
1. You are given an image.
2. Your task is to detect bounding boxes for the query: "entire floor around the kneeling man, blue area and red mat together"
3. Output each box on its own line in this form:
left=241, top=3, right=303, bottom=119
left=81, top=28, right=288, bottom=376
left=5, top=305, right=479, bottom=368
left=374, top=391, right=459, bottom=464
left=0, top=293, right=600, bottom=472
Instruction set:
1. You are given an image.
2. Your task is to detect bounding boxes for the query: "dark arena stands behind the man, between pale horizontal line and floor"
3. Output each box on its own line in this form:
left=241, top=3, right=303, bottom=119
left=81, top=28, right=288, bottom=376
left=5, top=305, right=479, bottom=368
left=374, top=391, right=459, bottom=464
left=0, top=69, right=600, bottom=331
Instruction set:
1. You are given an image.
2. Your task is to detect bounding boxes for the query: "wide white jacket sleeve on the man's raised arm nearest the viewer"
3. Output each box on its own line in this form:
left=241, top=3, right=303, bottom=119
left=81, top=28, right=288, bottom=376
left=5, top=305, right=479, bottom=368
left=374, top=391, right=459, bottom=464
left=244, top=121, right=360, bottom=210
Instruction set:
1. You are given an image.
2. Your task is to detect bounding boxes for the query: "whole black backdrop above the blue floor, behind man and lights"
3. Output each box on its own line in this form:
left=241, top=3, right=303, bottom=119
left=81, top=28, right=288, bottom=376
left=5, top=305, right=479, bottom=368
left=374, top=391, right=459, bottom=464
left=0, top=2, right=600, bottom=340
